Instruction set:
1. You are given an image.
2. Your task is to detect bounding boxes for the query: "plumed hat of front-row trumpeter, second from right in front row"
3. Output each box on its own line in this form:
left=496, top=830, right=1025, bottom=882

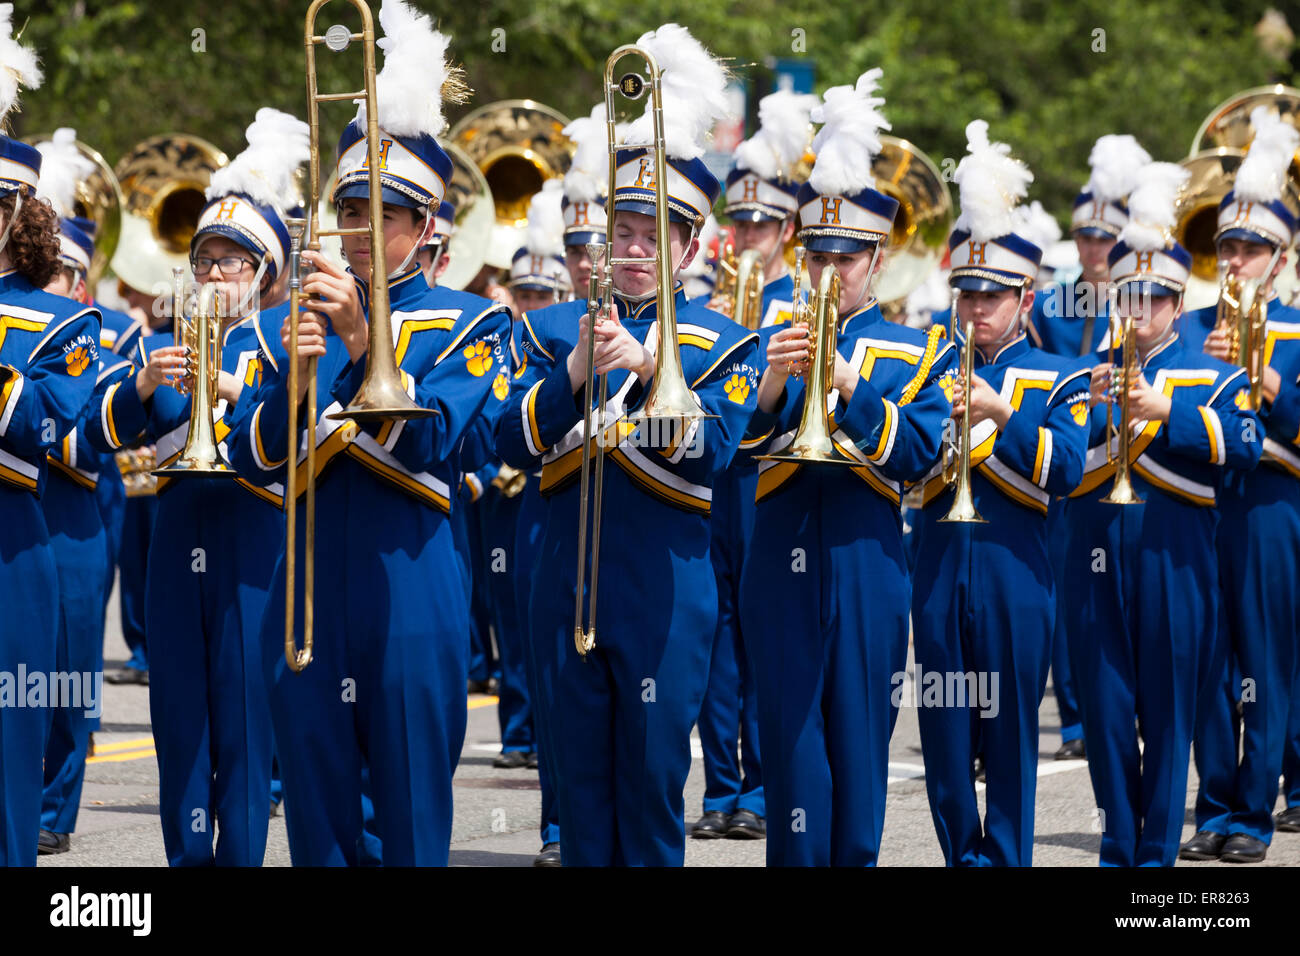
left=948, top=120, right=1043, bottom=293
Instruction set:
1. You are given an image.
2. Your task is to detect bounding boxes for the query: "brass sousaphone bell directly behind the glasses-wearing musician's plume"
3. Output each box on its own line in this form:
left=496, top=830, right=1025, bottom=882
left=112, top=133, right=228, bottom=293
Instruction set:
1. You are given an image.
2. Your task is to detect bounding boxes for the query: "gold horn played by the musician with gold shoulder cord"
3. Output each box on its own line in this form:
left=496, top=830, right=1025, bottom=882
left=757, top=260, right=857, bottom=464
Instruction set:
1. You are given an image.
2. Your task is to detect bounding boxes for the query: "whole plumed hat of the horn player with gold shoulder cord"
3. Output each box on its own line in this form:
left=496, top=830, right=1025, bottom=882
left=796, top=68, right=898, bottom=252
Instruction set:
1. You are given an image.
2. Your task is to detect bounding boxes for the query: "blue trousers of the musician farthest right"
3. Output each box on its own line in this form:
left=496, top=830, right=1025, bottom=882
left=1196, top=466, right=1300, bottom=843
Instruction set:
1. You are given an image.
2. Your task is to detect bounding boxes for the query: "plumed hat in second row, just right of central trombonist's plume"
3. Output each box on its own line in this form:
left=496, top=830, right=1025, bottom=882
left=723, top=90, right=819, bottom=222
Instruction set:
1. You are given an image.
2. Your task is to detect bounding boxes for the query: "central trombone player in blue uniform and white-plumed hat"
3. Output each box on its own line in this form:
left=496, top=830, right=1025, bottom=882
left=498, top=23, right=758, bottom=865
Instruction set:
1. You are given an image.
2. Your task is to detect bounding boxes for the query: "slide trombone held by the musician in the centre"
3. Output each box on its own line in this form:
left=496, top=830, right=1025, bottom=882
left=573, top=44, right=718, bottom=659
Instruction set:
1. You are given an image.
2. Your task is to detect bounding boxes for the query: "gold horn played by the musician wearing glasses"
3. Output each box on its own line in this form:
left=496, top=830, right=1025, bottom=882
left=153, top=269, right=235, bottom=477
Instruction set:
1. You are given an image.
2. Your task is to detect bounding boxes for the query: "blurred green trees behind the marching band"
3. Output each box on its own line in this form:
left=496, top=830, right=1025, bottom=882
left=13, top=0, right=1300, bottom=222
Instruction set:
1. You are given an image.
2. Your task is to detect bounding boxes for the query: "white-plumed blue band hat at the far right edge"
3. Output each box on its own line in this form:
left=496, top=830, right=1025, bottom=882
left=1214, top=107, right=1300, bottom=247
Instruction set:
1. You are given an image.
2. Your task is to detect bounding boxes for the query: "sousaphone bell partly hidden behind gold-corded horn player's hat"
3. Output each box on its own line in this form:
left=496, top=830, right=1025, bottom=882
left=871, top=135, right=953, bottom=311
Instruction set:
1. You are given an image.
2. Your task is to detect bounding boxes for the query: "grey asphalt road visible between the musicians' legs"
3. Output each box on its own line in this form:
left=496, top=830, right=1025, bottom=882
left=39, top=574, right=1300, bottom=866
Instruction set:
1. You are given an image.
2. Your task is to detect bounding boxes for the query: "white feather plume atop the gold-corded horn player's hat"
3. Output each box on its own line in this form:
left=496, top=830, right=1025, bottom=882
left=809, top=66, right=889, bottom=195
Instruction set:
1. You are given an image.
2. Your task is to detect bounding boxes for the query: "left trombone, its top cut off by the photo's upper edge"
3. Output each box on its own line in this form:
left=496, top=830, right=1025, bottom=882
left=285, top=0, right=434, bottom=672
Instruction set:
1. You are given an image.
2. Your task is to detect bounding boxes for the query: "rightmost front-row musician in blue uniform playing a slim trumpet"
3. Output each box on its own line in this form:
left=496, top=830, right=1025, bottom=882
left=1065, top=163, right=1260, bottom=866
